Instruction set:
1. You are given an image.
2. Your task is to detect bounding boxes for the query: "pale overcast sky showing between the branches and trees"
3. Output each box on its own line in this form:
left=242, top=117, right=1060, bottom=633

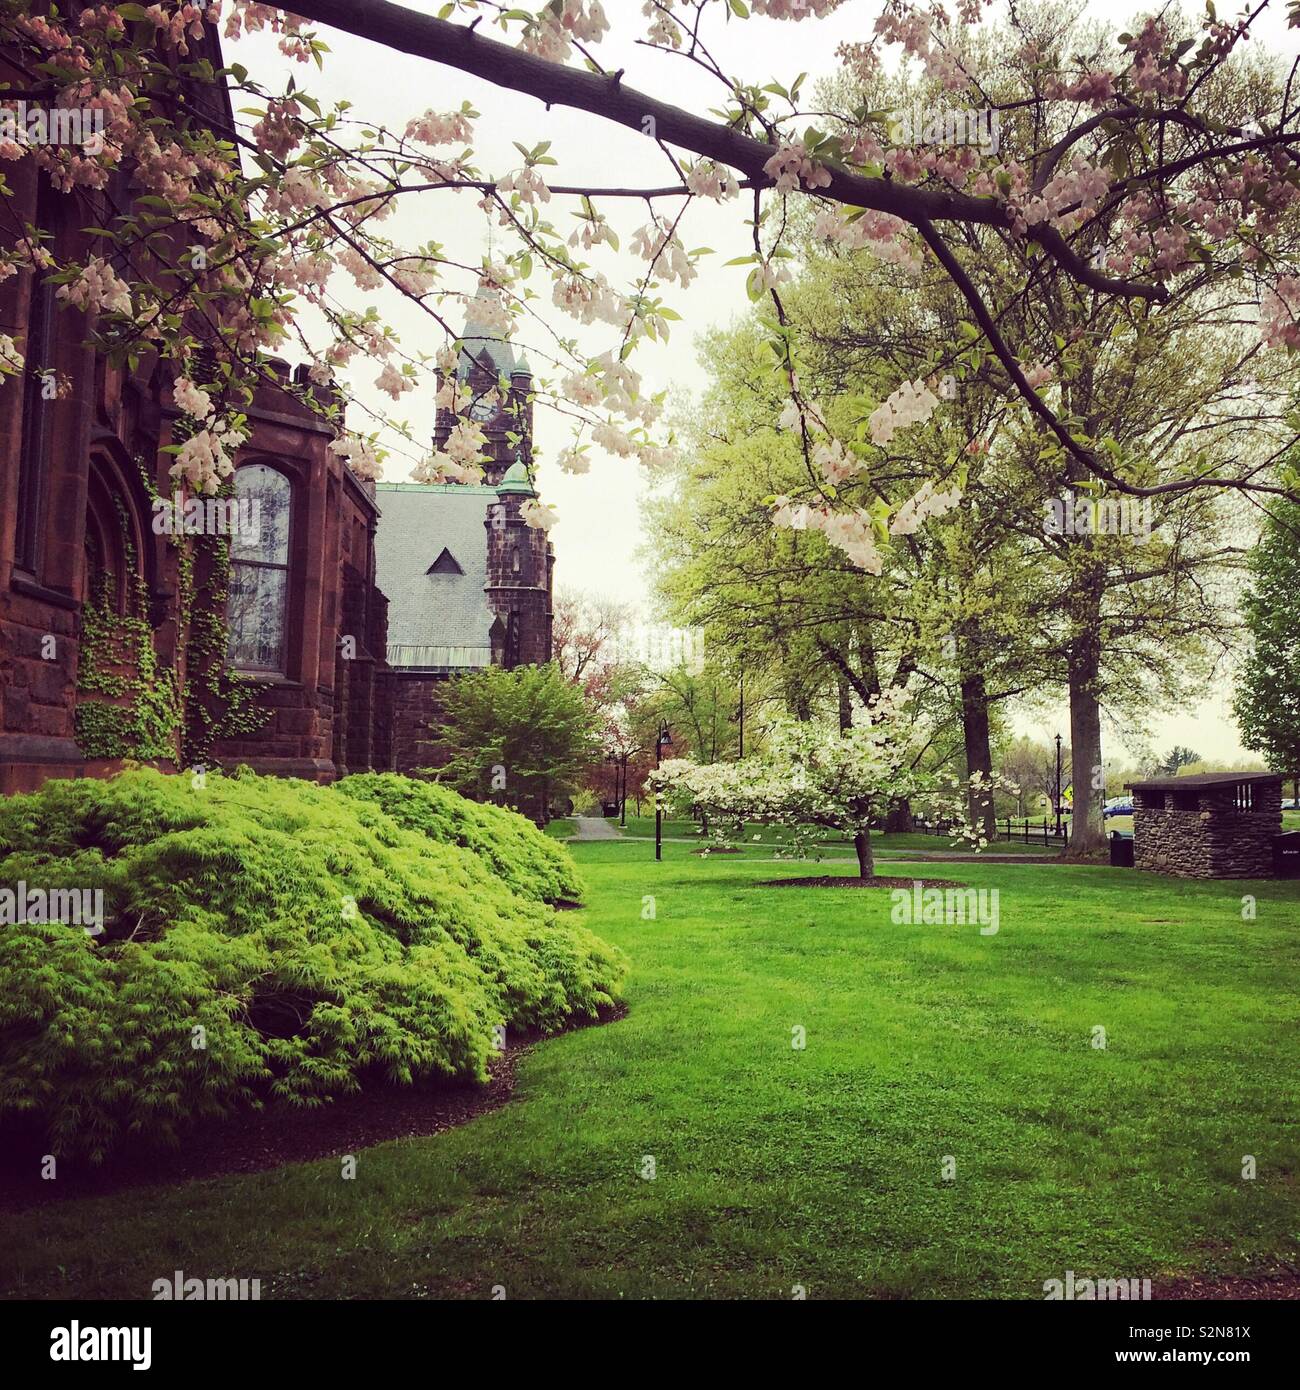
left=228, top=0, right=1300, bottom=758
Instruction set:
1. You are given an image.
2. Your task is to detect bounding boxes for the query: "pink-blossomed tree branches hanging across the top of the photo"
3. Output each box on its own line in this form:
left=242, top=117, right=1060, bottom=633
left=0, top=0, right=1300, bottom=550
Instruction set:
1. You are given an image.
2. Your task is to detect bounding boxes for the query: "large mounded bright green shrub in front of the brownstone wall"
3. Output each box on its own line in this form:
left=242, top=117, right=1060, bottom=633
left=0, top=770, right=624, bottom=1159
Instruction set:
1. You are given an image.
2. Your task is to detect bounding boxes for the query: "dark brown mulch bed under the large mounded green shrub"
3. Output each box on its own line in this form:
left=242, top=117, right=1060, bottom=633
left=0, top=1005, right=627, bottom=1211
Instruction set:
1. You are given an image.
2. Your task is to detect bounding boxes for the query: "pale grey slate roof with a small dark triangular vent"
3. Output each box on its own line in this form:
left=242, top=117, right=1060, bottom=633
left=375, top=482, right=496, bottom=670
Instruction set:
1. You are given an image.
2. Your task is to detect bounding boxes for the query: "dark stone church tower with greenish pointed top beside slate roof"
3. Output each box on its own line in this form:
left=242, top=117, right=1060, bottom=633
left=434, top=288, right=555, bottom=669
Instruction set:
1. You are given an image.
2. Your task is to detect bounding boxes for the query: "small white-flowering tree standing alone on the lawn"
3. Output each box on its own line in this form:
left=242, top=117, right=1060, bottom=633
left=649, top=691, right=1006, bottom=878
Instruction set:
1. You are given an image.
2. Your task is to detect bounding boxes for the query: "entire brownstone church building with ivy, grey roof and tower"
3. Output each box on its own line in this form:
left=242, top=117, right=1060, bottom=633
left=0, top=29, right=553, bottom=792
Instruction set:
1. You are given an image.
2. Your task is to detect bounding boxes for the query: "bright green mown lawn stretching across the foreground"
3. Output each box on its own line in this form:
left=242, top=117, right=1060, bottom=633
left=0, top=841, right=1300, bottom=1298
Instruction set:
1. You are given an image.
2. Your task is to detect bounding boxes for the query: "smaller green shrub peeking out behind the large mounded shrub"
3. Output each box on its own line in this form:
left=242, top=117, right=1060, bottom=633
left=334, top=773, right=584, bottom=902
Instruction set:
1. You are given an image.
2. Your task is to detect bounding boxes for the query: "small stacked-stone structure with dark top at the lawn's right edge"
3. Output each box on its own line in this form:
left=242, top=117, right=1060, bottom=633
left=1133, top=783, right=1282, bottom=878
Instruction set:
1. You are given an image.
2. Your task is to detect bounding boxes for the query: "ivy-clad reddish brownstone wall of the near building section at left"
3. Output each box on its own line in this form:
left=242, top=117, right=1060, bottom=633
left=0, top=29, right=391, bottom=791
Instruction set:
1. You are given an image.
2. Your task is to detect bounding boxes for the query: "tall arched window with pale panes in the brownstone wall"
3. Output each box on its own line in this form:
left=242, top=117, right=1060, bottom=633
left=227, top=463, right=293, bottom=673
